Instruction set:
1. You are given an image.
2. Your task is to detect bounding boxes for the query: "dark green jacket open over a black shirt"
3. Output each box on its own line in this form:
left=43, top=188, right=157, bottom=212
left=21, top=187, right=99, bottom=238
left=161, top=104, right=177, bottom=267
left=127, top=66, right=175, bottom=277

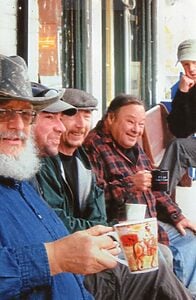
left=37, top=148, right=107, bottom=232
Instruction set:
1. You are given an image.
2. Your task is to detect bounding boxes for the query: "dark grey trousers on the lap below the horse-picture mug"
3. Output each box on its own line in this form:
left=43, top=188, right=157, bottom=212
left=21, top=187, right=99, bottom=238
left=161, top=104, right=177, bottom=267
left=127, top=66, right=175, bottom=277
left=85, top=261, right=192, bottom=300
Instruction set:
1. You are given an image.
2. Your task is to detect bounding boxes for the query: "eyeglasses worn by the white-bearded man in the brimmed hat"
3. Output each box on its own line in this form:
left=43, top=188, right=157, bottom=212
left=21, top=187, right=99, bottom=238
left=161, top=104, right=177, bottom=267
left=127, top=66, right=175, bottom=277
left=0, top=108, right=36, bottom=125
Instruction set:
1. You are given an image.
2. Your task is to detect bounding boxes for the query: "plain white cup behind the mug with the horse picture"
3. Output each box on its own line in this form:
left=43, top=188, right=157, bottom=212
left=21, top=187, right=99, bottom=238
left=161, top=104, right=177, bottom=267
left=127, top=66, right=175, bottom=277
left=125, top=203, right=146, bottom=220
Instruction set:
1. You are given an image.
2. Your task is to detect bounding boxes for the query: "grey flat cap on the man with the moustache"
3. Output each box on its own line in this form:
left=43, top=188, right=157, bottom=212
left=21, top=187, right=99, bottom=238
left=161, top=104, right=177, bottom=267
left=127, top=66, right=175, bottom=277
left=61, top=88, right=98, bottom=110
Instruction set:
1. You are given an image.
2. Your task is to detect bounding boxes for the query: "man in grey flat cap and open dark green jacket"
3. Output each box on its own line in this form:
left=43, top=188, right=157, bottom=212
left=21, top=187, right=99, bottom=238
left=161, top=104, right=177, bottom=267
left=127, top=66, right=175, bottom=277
left=37, top=88, right=107, bottom=232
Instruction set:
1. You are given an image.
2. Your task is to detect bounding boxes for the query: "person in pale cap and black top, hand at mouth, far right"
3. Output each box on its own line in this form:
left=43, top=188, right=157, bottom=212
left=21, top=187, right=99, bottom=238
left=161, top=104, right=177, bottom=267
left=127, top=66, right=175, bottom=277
left=160, top=39, right=196, bottom=194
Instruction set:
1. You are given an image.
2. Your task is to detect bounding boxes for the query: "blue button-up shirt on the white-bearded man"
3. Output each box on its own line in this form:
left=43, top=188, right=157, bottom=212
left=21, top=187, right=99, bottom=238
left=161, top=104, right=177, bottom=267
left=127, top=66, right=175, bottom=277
left=0, top=178, right=93, bottom=300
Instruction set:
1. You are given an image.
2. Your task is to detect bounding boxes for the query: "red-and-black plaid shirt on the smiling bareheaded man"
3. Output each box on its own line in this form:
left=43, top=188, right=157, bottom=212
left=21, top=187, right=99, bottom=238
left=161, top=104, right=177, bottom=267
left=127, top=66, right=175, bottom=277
left=85, top=121, right=184, bottom=244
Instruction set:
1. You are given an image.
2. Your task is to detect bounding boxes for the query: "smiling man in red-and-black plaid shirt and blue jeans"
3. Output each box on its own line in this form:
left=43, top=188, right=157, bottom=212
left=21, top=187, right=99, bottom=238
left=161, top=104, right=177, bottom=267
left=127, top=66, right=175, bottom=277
left=85, top=95, right=196, bottom=296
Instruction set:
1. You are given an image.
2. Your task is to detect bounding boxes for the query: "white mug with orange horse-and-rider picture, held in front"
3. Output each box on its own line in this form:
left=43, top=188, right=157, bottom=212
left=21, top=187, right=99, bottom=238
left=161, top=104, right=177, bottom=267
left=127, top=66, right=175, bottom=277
left=114, top=218, right=158, bottom=273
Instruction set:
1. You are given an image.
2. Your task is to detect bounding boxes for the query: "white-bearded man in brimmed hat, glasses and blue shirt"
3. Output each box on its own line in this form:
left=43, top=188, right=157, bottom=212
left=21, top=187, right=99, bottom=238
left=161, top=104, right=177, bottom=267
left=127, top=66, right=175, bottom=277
left=0, top=55, right=119, bottom=300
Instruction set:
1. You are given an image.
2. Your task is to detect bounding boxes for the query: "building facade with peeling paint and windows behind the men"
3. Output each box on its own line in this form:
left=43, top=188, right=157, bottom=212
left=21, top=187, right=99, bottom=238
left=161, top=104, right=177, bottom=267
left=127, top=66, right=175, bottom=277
left=0, top=0, right=196, bottom=122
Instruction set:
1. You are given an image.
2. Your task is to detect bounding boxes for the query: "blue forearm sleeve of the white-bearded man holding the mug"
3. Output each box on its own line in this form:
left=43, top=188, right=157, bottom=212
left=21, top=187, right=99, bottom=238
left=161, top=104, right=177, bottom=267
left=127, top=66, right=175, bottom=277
left=0, top=244, right=51, bottom=299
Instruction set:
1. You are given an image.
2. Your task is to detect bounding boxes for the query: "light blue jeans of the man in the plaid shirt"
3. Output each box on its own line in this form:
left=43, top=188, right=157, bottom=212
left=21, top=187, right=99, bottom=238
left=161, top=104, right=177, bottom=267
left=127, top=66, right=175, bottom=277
left=161, top=222, right=196, bottom=296
